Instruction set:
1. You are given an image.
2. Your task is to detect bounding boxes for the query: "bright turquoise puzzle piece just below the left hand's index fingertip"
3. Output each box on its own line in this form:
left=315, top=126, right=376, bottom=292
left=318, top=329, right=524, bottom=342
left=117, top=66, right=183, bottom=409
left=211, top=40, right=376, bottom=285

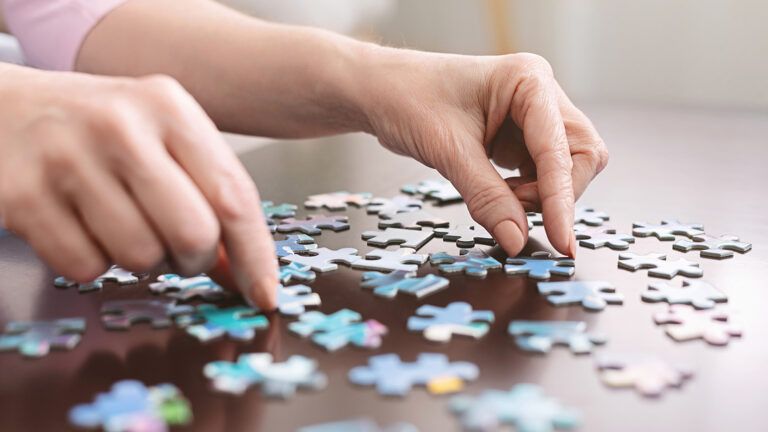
left=176, top=304, right=269, bottom=342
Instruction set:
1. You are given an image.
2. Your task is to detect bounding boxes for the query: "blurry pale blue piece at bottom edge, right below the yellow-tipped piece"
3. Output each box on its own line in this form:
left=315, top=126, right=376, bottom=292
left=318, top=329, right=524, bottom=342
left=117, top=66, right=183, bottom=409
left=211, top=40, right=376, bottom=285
left=450, top=384, right=580, bottom=432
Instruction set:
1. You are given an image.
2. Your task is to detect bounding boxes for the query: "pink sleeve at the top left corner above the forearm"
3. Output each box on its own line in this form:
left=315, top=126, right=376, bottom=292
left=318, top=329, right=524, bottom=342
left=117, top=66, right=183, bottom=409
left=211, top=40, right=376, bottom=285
left=3, top=0, right=128, bottom=70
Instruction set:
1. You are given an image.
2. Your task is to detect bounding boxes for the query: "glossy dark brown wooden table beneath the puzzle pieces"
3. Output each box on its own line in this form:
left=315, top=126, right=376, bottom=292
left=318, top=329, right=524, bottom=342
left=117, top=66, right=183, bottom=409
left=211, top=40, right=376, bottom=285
left=0, top=106, right=768, bottom=431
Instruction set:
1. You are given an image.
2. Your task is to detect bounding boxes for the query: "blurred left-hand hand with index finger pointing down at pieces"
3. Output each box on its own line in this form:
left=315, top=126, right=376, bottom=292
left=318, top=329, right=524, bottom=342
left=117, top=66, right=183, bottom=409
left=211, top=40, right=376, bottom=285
left=0, top=66, right=277, bottom=309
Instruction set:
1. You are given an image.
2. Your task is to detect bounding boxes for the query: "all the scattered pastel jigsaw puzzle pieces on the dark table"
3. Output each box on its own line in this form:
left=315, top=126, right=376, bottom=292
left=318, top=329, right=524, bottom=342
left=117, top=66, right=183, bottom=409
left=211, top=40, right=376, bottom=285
left=0, top=180, right=751, bottom=432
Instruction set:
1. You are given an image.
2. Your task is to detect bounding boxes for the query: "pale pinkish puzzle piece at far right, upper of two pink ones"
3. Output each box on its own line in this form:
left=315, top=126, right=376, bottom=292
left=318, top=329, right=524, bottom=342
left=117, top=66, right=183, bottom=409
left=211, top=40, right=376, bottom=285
left=653, top=305, right=743, bottom=345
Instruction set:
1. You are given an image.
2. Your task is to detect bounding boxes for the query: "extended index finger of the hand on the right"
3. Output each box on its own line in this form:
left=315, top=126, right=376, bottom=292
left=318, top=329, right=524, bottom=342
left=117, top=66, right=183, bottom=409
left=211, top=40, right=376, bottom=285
left=511, top=57, right=576, bottom=256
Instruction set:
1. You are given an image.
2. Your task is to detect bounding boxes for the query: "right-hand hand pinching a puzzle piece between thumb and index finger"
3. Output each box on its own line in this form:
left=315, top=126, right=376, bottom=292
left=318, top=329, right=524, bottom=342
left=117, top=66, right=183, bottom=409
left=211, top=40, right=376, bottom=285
left=360, top=48, right=608, bottom=256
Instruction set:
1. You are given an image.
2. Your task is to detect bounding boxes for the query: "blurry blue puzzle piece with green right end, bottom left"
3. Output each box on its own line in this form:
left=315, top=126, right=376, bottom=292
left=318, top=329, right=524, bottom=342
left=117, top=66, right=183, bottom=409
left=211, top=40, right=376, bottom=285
left=69, top=380, right=192, bottom=432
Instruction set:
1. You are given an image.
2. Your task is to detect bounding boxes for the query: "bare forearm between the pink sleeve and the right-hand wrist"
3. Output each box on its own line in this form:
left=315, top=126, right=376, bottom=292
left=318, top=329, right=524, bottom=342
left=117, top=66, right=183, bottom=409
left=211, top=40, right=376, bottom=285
left=76, top=0, right=370, bottom=137
